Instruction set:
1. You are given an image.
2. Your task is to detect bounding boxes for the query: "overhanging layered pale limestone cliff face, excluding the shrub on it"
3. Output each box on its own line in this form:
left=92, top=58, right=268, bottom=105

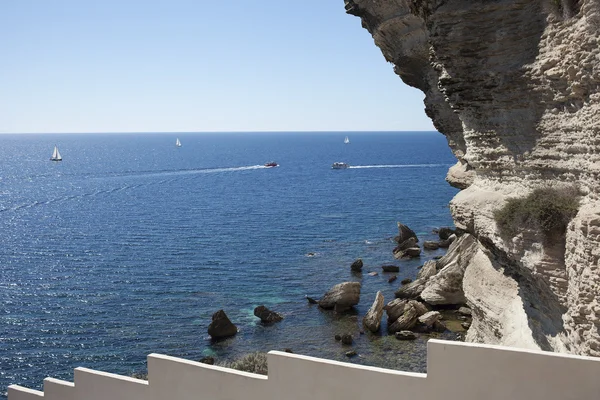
left=345, top=0, right=600, bottom=356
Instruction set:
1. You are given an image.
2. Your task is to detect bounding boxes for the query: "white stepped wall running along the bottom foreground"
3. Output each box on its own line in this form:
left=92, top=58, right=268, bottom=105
left=8, top=340, right=600, bottom=400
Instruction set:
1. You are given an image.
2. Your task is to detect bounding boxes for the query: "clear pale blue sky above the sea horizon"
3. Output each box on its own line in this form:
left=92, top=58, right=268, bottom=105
left=0, top=0, right=434, bottom=133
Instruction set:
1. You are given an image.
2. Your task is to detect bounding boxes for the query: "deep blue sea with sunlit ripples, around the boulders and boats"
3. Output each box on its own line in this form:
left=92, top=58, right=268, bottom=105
left=0, top=132, right=456, bottom=397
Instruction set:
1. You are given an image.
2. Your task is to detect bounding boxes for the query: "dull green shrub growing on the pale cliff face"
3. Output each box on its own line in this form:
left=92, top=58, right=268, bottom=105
left=494, top=187, right=580, bottom=237
